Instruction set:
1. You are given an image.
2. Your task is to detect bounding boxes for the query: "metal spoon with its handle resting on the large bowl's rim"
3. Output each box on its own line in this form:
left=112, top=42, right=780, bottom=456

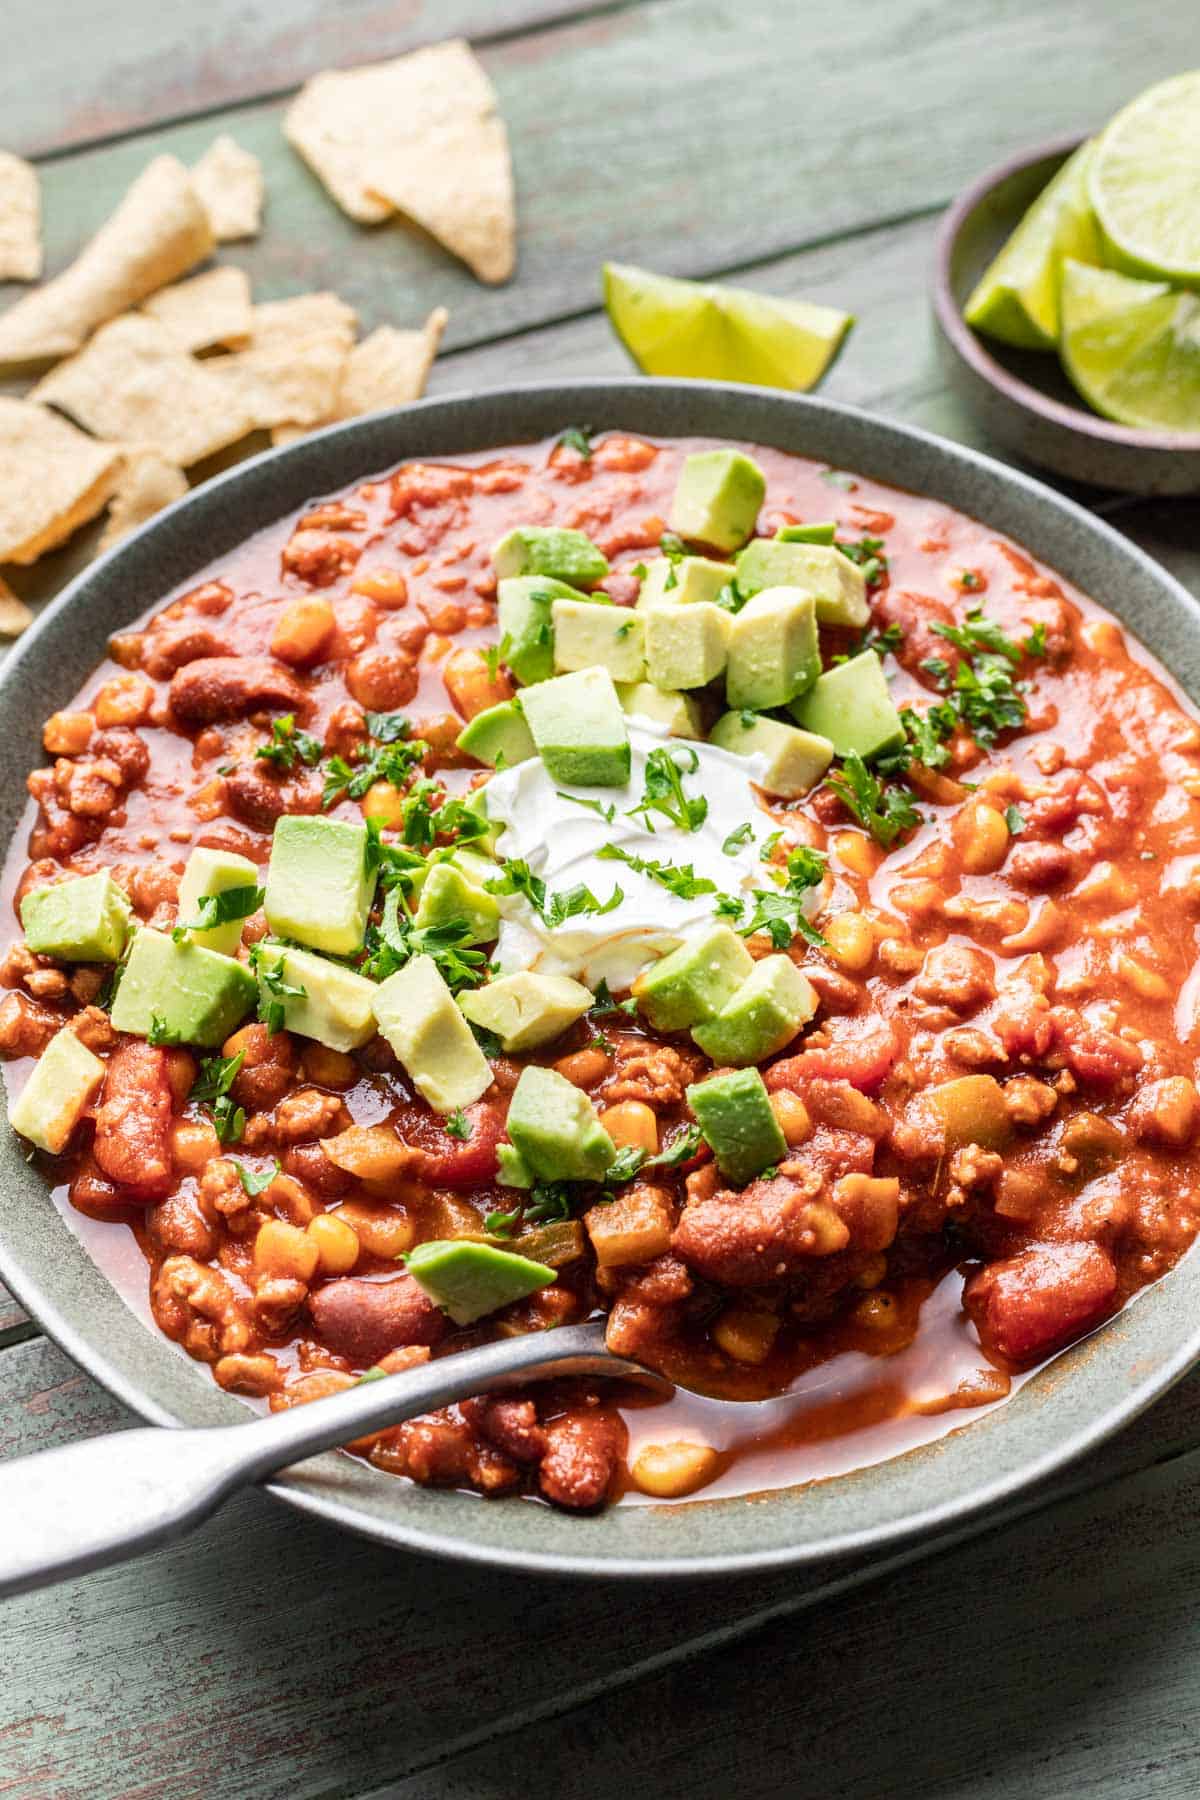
left=0, top=1321, right=669, bottom=1598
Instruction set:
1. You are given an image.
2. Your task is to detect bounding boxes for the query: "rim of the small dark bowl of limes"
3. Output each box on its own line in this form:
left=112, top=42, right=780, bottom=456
left=934, top=131, right=1200, bottom=455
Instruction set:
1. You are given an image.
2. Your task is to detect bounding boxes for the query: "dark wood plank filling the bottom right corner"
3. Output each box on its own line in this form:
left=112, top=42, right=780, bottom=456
left=385, top=1454, right=1200, bottom=1800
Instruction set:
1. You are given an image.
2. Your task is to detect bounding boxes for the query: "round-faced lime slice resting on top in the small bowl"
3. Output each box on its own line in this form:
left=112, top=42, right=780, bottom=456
left=1088, top=68, right=1200, bottom=286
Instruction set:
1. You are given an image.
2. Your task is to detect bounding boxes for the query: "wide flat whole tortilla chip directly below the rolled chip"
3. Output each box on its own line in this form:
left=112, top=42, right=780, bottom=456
left=31, top=313, right=254, bottom=468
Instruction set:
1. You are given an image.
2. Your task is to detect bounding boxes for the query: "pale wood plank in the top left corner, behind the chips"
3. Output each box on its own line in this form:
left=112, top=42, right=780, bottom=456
left=4, top=0, right=608, bottom=155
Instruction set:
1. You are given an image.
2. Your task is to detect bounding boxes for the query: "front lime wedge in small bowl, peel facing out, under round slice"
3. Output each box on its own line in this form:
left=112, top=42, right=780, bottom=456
left=1060, top=259, right=1200, bottom=432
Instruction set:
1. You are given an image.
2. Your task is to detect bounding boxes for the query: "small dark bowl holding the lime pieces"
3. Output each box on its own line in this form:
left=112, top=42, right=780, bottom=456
left=934, top=137, right=1200, bottom=493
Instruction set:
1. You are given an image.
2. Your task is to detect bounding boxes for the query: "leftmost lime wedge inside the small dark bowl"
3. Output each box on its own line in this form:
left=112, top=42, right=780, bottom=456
left=963, top=144, right=1099, bottom=349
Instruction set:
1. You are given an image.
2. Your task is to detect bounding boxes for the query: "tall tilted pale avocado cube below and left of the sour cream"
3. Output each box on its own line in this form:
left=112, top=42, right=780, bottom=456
left=374, top=956, right=491, bottom=1112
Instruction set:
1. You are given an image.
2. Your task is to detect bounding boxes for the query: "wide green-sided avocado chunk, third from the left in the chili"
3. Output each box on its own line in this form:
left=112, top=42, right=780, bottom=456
left=112, top=925, right=257, bottom=1049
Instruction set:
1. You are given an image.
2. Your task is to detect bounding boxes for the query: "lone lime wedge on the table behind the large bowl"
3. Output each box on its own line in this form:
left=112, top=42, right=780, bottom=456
left=604, top=263, right=855, bottom=391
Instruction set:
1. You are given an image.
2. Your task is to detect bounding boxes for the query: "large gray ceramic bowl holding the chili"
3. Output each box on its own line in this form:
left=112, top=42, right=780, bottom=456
left=0, top=380, right=1200, bottom=1577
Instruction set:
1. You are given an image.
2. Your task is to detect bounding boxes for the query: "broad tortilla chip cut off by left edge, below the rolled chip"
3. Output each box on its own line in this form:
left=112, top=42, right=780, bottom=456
left=0, top=398, right=121, bottom=563
